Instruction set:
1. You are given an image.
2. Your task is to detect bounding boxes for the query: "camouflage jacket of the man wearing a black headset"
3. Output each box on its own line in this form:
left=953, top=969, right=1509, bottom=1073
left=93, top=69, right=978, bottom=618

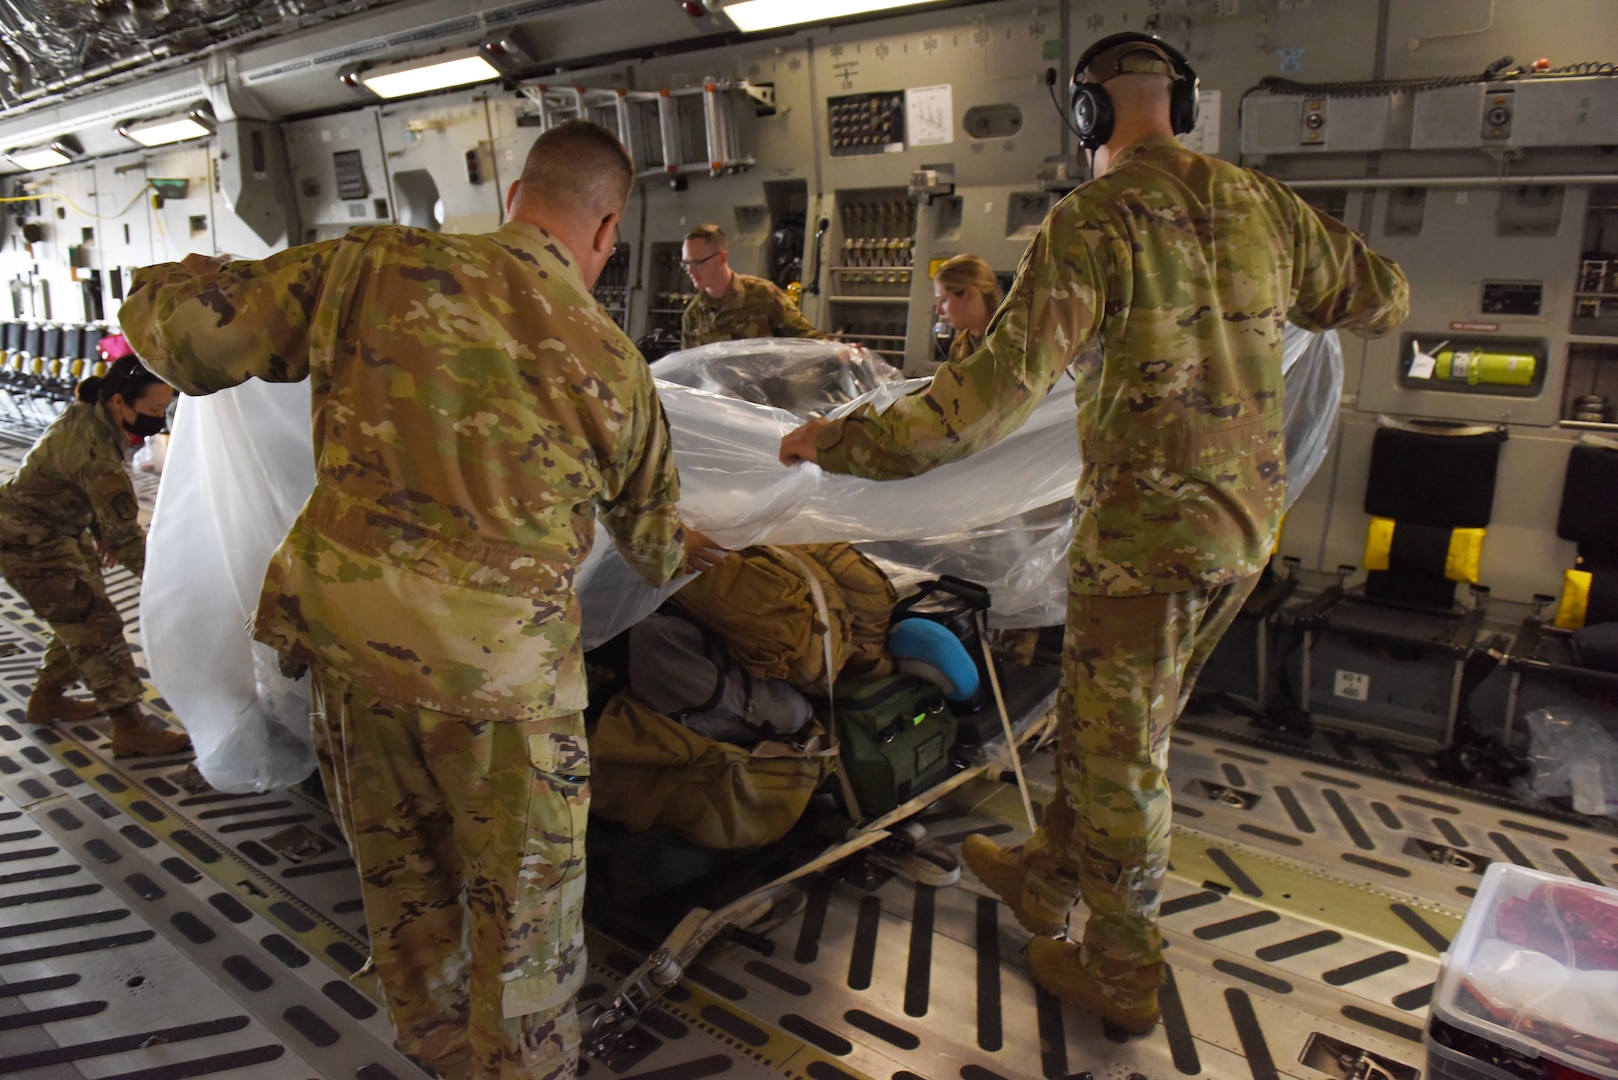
left=817, top=136, right=1409, bottom=596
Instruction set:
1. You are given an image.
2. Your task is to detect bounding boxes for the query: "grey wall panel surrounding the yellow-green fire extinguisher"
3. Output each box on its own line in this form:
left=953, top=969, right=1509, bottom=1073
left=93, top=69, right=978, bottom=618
left=1359, top=186, right=1589, bottom=426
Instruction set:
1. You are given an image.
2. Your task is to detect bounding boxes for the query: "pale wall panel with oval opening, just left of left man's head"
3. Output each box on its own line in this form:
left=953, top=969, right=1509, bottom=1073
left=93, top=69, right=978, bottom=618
left=377, top=91, right=505, bottom=233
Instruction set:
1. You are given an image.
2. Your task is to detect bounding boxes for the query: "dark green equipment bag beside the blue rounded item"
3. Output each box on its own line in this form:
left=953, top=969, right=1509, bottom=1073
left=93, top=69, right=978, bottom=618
left=815, top=675, right=955, bottom=818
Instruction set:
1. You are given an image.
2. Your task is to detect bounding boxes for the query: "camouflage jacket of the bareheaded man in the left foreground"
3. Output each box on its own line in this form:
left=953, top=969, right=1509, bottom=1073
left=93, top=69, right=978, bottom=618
left=120, top=223, right=684, bottom=719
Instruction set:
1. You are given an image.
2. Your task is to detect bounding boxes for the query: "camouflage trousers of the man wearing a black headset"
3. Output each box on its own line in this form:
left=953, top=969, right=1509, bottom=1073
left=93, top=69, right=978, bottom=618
left=1024, top=575, right=1259, bottom=1006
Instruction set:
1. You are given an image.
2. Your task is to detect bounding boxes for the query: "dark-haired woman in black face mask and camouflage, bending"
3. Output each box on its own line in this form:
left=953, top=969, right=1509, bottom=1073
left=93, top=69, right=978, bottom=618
left=0, top=351, right=191, bottom=756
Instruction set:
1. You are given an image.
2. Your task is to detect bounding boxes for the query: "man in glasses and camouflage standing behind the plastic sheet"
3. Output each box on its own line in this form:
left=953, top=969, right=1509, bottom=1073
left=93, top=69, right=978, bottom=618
left=680, top=225, right=828, bottom=348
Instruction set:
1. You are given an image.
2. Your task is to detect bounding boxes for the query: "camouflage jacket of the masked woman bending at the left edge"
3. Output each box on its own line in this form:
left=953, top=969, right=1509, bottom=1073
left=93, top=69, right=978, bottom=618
left=0, top=402, right=146, bottom=576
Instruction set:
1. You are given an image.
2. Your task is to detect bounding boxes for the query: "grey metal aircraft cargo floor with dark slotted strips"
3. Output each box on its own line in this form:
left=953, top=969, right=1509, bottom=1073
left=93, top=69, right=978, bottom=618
left=0, top=424, right=1618, bottom=1080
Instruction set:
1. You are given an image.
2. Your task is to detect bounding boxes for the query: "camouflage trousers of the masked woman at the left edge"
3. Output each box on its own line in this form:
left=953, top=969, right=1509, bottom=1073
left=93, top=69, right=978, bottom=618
left=0, top=534, right=144, bottom=709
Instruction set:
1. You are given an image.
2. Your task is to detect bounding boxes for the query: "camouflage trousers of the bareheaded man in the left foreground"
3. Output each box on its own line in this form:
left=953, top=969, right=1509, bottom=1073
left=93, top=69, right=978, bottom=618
left=314, top=670, right=591, bottom=1080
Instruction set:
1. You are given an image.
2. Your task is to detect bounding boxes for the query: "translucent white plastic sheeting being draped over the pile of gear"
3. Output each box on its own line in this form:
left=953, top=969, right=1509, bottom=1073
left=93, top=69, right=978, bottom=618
left=141, top=327, right=1343, bottom=792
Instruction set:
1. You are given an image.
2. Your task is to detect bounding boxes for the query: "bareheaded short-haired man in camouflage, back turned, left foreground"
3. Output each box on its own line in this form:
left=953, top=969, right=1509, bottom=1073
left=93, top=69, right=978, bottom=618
left=120, top=121, right=715, bottom=1080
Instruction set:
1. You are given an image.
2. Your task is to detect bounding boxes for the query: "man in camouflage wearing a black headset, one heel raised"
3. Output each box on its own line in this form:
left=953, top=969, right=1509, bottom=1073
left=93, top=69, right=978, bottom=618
left=781, top=34, right=1408, bottom=1033
